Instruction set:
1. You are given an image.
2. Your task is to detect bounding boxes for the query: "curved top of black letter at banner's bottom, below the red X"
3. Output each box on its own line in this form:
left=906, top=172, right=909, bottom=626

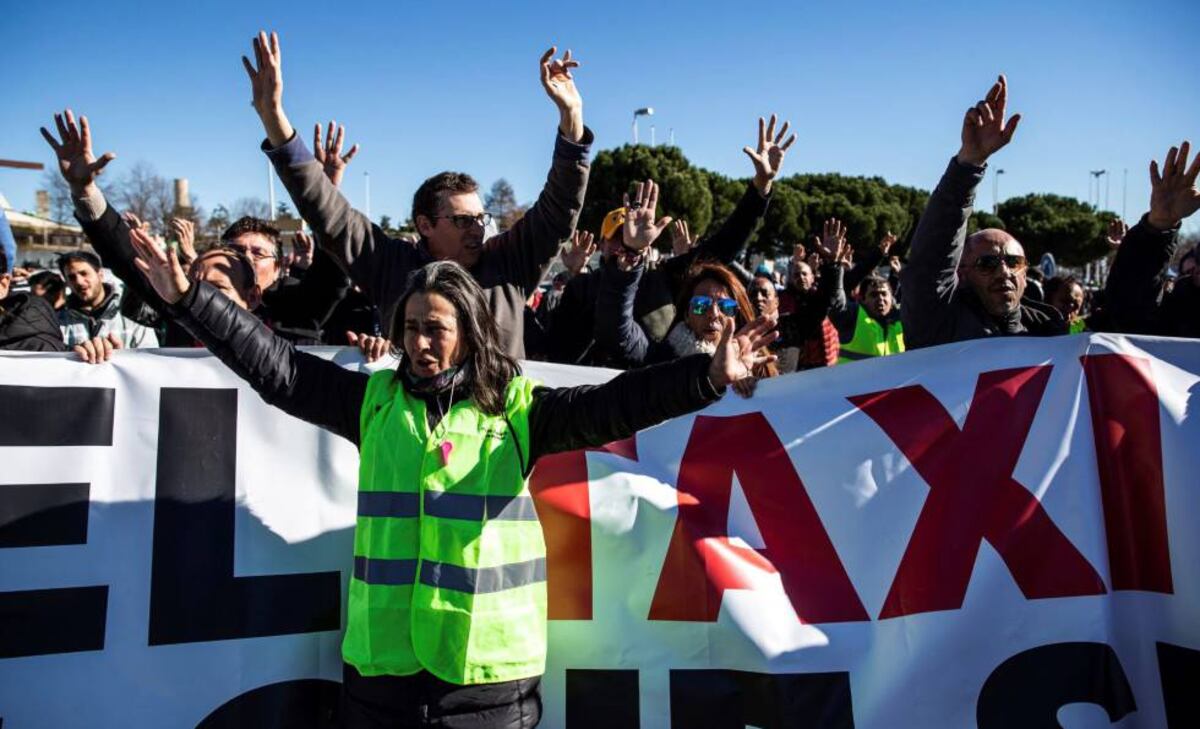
left=976, top=643, right=1138, bottom=729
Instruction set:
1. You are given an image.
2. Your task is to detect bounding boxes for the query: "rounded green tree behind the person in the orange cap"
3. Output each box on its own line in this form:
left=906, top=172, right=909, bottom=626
left=580, top=144, right=710, bottom=245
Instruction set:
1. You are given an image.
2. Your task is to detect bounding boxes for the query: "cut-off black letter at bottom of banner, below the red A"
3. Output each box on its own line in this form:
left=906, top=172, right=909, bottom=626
left=671, top=669, right=854, bottom=729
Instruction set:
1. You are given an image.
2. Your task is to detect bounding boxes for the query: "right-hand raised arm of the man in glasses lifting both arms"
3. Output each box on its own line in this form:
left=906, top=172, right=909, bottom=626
left=484, top=48, right=594, bottom=294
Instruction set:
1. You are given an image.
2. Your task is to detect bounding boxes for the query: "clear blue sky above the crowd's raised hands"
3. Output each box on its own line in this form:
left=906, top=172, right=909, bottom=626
left=0, top=0, right=1200, bottom=230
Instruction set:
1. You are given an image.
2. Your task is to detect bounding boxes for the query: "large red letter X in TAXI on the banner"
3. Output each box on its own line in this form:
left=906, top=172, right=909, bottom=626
left=850, top=367, right=1104, bottom=619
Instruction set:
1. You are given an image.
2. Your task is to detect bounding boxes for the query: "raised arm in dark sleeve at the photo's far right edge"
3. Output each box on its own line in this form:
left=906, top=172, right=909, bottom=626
left=1105, top=141, right=1200, bottom=335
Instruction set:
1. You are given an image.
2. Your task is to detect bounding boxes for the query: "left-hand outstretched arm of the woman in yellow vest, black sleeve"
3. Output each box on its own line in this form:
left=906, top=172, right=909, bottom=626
left=130, top=225, right=367, bottom=445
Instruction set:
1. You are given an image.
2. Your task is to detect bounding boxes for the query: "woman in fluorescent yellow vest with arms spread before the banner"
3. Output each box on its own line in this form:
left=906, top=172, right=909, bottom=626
left=131, top=231, right=774, bottom=728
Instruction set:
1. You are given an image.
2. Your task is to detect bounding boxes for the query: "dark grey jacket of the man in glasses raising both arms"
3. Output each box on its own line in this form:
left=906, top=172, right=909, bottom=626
left=263, top=129, right=593, bottom=359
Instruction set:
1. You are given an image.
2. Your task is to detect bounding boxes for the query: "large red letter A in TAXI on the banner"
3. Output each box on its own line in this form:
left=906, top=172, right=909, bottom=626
left=649, top=412, right=870, bottom=623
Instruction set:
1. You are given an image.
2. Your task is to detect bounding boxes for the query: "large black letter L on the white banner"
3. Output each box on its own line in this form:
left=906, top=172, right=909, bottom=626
left=149, top=387, right=342, bottom=645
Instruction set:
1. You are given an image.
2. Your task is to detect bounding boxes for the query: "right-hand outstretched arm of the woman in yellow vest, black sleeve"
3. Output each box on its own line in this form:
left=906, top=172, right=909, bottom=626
left=529, top=319, right=775, bottom=465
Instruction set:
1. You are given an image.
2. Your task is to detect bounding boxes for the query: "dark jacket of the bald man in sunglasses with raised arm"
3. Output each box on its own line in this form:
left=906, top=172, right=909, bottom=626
left=900, top=158, right=1067, bottom=349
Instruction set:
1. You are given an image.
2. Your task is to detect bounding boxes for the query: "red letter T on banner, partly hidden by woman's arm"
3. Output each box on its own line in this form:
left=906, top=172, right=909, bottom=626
left=529, top=438, right=637, bottom=620
